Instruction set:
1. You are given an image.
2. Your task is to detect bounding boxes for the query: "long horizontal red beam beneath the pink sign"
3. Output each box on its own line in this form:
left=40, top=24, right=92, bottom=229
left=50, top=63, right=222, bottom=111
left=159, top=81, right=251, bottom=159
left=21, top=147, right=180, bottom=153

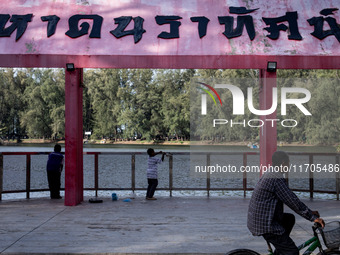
left=0, top=54, right=340, bottom=69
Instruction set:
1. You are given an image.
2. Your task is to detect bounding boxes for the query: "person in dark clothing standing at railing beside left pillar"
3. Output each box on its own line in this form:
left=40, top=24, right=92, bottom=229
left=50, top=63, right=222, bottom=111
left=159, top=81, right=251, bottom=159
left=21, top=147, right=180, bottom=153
left=46, top=144, right=64, bottom=199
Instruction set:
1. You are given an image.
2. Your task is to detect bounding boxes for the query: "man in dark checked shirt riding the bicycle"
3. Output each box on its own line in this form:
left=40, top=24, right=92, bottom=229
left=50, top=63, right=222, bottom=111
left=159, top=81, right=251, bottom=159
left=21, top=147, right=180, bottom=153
left=247, top=151, right=325, bottom=255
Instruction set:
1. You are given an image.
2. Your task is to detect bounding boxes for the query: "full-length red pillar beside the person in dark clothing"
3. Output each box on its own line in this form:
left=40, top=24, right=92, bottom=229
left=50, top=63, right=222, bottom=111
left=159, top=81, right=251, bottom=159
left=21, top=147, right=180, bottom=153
left=65, top=68, right=84, bottom=206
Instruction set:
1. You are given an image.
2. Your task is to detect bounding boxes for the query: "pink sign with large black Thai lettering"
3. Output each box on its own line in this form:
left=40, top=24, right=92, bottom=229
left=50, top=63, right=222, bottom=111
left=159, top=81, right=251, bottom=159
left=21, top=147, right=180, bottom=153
left=0, top=0, right=340, bottom=56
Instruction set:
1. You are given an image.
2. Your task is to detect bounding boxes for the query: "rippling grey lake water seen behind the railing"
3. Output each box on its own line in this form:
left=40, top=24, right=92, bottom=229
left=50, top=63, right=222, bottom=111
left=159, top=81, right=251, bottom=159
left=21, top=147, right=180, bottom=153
left=0, top=144, right=336, bottom=198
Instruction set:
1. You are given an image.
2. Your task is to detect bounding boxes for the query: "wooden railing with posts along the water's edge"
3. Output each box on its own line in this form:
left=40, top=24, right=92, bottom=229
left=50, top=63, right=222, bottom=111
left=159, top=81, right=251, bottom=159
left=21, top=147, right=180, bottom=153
left=0, top=152, right=340, bottom=200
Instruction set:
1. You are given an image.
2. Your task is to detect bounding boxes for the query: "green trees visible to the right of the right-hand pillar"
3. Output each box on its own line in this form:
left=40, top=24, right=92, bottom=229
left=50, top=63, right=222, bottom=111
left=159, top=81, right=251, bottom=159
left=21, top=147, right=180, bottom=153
left=278, top=70, right=340, bottom=144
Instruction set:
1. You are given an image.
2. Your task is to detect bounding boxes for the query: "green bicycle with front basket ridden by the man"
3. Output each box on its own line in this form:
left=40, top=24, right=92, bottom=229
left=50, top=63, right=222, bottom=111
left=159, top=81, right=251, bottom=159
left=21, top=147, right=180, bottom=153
left=226, top=221, right=340, bottom=255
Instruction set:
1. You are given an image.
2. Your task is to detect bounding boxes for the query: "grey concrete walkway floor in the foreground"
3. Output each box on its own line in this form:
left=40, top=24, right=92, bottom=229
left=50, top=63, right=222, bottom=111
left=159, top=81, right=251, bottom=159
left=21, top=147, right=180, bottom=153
left=0, top=197, right=340, bottom=255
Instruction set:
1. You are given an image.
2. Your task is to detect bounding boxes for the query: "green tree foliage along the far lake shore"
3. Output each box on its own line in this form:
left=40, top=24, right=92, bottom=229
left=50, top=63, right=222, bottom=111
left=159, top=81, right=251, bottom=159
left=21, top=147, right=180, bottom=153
left=0, top=69, right=340, bottom=144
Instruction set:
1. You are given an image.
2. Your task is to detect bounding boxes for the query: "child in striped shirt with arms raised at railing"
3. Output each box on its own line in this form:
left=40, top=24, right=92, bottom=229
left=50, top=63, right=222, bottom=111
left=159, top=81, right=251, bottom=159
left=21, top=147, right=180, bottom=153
left=146, top=148, right=166, bottom=200
